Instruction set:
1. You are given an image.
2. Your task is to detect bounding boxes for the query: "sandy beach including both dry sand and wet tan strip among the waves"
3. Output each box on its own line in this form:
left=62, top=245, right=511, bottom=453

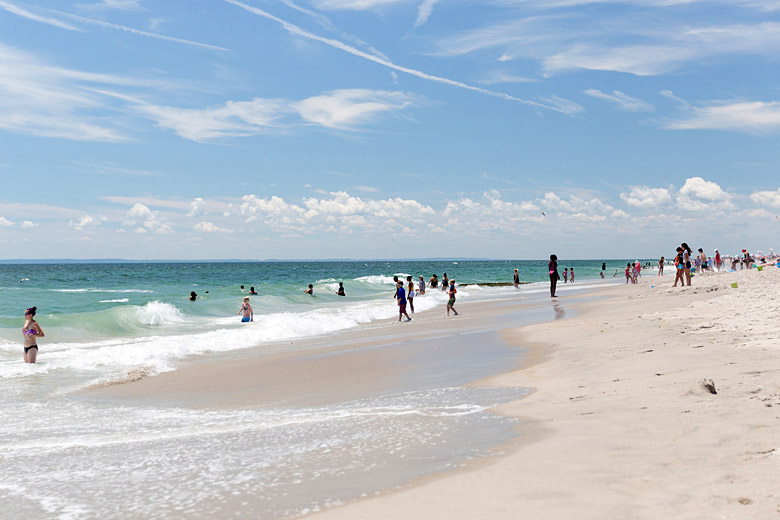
left=77, top=267, right=780, bottom=519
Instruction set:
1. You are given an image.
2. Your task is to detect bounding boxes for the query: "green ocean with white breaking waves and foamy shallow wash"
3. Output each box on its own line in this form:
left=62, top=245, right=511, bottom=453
left=0, top=260, right=626, bottom=519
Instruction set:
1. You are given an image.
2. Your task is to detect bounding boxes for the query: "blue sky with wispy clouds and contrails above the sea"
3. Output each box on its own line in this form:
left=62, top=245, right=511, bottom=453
left=0, top=0, right=780, bottom=260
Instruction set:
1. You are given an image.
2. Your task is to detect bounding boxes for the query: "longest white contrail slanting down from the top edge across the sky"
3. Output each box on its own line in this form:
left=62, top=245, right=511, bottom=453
left=224, top=0, right=561, bottom=112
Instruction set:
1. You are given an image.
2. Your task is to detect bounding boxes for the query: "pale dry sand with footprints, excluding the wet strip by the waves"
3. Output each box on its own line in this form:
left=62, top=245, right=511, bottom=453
left=314, top=268, right=780, bottom=520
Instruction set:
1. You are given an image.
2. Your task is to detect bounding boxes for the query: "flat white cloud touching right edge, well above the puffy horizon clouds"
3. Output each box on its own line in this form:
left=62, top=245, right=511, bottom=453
left=666, top=101, right=780, bottom=133
